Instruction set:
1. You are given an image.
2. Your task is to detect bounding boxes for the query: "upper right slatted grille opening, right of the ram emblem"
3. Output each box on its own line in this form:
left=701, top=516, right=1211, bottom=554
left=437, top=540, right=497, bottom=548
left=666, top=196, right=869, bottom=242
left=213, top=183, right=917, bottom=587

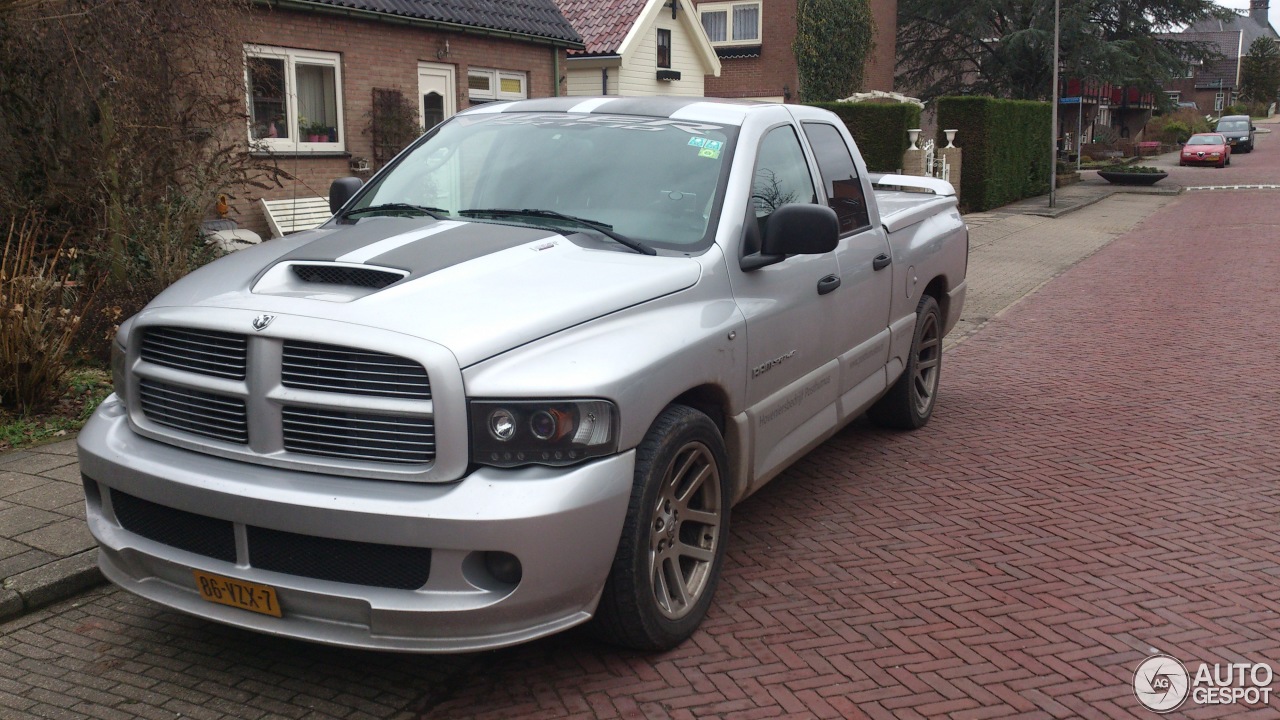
left=282, top=340, right=431, bottom=400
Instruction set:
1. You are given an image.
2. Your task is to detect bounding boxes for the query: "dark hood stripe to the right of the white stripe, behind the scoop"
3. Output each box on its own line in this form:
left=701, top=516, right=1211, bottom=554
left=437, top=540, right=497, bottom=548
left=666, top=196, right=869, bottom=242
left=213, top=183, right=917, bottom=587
left=367, top=223, right=558, bottom=277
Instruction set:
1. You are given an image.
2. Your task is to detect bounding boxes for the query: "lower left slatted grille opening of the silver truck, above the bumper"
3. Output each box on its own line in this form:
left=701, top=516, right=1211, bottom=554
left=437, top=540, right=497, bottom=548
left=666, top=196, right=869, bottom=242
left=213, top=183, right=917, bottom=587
left=138, top=378, right=248, bottom=445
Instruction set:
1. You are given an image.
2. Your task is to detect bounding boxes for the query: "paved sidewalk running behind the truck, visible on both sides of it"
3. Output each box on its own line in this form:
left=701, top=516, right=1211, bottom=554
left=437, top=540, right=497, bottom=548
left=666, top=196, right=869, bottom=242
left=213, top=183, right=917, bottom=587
left=0, top=165, right=1180, bottom=620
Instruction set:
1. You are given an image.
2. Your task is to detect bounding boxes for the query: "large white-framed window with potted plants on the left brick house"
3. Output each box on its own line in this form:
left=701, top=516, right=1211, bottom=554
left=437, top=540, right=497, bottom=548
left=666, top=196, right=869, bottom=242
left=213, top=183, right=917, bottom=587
left=244, top=45, right=346, bottom=152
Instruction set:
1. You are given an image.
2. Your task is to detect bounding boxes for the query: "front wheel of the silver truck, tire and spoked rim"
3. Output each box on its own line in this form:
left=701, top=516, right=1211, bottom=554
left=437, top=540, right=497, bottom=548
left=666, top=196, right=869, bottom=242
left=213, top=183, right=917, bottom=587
left=589, top=405, right=731, bottom=650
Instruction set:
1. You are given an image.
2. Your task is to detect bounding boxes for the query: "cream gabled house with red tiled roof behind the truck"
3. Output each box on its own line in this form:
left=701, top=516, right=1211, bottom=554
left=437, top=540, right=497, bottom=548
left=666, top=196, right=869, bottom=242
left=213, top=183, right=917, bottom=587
left=556, top=0, right=721, bottom=97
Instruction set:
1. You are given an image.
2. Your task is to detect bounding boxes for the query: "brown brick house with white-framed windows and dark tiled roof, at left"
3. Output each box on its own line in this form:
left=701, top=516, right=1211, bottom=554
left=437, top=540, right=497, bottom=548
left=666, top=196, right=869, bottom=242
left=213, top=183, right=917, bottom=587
left=230, top=0, right=582, bottom=237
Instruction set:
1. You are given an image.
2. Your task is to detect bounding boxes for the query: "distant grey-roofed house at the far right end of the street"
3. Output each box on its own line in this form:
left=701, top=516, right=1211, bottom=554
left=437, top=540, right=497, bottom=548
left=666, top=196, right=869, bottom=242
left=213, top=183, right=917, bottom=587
left=1165, top=0, right=1280, bottom=114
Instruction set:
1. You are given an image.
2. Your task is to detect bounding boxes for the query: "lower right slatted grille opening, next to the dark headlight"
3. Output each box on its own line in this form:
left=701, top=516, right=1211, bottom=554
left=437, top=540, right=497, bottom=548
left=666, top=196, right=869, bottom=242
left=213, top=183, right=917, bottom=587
left=284, top=407, right=435, bottom=465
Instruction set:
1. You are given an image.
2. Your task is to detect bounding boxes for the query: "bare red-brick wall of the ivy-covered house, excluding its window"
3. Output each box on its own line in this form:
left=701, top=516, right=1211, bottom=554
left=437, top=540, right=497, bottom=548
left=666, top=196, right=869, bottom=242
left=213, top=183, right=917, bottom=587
left=695, top=0, right=897, bottom=101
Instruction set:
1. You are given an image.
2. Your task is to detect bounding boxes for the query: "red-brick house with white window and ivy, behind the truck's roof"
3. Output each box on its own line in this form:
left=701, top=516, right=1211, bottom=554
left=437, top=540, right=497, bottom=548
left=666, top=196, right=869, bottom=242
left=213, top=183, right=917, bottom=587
left=694, top=0, right=897, bottom=102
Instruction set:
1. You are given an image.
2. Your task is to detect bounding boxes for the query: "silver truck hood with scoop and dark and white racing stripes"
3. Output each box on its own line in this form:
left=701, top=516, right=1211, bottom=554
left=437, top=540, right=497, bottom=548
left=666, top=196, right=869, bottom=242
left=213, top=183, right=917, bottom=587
left=148, top=218, right=700, bottom=368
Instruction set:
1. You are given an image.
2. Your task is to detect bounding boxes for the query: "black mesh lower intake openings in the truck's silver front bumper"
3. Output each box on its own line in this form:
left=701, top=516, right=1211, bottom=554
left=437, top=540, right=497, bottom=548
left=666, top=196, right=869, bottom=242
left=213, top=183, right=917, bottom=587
left=110, top=489, right=431, bottom=591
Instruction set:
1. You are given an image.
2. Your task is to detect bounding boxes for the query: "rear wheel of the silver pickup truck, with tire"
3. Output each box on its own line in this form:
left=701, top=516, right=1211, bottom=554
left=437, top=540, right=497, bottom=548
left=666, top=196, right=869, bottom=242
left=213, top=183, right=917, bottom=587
left=867, top=295, right=942, bottom=430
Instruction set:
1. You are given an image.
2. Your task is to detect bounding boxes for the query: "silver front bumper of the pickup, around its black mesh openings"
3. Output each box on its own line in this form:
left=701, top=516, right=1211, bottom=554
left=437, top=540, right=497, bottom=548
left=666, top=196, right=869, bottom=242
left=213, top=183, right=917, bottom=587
left=79, top=396, right=635, bottom=652
